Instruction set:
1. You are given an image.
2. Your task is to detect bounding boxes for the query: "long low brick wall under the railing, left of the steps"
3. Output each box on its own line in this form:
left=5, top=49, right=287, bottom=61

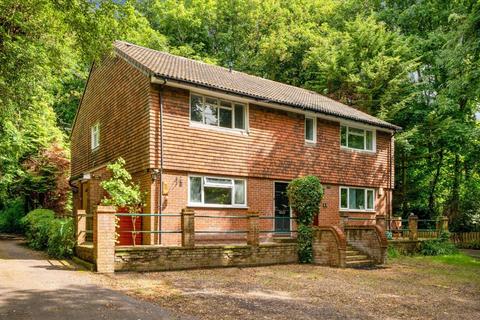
left=115, top=243, right=298, bottom=271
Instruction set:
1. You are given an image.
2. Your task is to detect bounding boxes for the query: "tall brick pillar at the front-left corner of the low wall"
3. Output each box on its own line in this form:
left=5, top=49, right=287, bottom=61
left=93, top=206, right=115, bottom=273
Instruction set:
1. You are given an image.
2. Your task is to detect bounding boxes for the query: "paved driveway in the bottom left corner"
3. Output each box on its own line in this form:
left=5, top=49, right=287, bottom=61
left=0, top=237, right=188, bottom=320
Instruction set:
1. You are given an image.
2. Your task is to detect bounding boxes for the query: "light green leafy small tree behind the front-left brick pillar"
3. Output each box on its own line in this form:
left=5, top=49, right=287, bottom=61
left=100, top=158, right=145, bottom=213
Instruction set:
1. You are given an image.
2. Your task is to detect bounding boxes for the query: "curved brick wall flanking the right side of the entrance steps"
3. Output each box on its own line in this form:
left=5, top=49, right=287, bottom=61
left=344, top=225, right=388, bottom=264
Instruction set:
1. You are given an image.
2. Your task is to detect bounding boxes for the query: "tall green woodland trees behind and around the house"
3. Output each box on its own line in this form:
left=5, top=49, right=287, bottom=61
left=0, top=0, right=480, bottom=231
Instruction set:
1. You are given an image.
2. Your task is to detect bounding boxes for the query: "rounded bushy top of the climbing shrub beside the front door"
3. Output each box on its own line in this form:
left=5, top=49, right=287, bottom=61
left=287, top=176, right=323, bottom=226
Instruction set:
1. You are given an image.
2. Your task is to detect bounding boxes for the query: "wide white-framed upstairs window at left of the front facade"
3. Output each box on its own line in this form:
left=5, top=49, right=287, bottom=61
left=190, top=93, right=247, bottom=130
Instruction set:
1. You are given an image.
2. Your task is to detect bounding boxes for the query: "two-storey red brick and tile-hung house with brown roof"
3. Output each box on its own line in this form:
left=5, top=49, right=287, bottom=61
left=71, top=41, right=399, bottom=244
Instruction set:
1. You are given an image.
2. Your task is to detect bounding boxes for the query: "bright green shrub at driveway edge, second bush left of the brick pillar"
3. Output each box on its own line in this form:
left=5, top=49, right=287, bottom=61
left=21, top=209, right=55, bottom=250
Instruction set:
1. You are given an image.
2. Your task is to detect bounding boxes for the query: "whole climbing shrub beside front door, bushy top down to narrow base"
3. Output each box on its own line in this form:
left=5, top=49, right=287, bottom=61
left=287, top=176, right=323, bottom=263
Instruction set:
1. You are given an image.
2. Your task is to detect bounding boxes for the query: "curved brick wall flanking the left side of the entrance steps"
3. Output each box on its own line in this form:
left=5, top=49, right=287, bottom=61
left=313, top=226, right=347, bottom=268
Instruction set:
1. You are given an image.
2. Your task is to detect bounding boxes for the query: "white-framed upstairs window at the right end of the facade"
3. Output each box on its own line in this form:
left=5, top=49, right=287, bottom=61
left=340, top=125, right=376, bottom=151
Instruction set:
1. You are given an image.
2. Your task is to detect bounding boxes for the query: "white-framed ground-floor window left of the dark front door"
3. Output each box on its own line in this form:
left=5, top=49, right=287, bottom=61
left=188, top=175, right=247, bottom=207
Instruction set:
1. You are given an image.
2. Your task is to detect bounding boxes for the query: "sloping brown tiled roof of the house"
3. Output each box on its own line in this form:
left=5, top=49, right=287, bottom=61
left=115, top=41, right=400, bottom=130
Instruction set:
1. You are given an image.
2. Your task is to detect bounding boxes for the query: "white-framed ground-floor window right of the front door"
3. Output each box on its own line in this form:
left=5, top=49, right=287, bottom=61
left=340, top=187, right=375, bottom=211
